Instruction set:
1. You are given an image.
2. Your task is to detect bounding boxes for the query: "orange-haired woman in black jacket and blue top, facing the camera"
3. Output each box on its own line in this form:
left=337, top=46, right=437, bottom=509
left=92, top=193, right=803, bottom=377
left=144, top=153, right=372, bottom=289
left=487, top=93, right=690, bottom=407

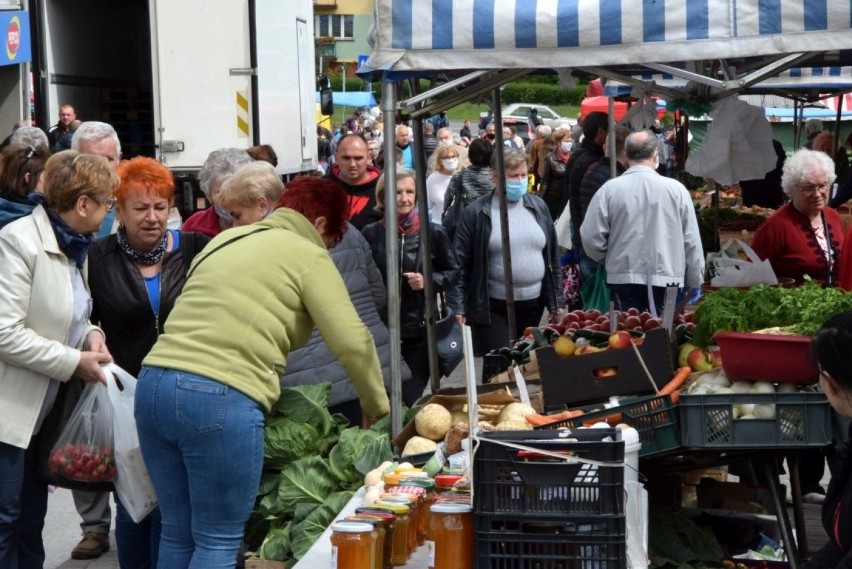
left=89, top=156, right=210, bottom=569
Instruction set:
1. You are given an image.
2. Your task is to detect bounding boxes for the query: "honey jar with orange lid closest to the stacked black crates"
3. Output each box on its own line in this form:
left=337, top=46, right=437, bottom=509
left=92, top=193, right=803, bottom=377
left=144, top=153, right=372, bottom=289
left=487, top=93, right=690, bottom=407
left=428, top=503, right=473, bottom=569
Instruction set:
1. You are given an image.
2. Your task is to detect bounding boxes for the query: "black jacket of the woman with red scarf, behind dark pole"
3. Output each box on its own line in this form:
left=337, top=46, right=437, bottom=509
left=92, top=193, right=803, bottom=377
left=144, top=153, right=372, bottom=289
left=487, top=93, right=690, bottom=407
left=361, top=221, right=461, bottom=338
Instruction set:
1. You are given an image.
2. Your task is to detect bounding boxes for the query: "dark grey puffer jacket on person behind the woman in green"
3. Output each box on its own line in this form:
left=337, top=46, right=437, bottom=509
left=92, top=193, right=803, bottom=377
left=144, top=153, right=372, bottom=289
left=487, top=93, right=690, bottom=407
left=281, top=225, right=411, bottom=406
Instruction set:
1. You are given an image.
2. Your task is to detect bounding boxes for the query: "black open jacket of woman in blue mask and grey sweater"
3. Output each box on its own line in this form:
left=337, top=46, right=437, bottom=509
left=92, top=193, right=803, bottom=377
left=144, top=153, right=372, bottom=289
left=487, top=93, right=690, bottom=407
left=453, top=194, right=565, bottom=324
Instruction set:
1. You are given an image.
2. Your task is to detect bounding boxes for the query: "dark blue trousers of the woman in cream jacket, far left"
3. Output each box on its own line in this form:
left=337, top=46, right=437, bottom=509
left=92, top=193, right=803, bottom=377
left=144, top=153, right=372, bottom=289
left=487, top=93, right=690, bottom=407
left=0, top=436, right=47, bottom=569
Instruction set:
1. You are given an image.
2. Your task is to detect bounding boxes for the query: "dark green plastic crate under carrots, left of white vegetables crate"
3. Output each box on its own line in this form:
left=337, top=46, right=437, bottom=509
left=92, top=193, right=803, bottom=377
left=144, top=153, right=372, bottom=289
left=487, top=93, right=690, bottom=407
left=536, top=395, right=681, bottom=457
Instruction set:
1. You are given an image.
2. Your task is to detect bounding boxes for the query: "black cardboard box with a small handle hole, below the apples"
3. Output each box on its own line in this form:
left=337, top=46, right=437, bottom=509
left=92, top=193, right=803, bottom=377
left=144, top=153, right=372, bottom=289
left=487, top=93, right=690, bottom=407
left=536, top=328, right=674, bottom=408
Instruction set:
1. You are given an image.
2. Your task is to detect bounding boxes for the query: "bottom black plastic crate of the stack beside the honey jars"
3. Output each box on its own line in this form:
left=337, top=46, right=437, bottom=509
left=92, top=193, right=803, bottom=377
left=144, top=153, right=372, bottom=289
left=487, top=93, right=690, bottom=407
left=474, top=515, right=627, bottom=569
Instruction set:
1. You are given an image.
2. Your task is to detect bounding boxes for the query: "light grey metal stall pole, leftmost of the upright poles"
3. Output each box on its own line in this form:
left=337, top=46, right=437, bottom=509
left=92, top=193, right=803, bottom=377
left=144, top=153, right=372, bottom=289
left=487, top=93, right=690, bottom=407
left=382, top=82, right=402, bottom=437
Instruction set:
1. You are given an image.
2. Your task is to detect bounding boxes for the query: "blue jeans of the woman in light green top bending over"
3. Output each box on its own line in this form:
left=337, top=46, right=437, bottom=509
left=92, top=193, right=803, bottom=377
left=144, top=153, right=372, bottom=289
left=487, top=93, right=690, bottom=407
left=136, top=367, right=263, bottom=569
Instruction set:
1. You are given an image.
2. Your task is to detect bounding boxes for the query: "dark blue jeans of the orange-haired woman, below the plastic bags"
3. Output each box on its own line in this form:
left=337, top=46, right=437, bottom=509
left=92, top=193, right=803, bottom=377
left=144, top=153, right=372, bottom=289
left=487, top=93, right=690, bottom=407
left=113, top=493, right=162, bottom=569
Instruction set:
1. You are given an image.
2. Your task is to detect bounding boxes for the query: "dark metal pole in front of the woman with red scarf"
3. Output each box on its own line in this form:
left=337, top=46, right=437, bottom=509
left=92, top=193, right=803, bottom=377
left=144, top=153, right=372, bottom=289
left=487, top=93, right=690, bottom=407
left=412, top=117, right=441, bottom=394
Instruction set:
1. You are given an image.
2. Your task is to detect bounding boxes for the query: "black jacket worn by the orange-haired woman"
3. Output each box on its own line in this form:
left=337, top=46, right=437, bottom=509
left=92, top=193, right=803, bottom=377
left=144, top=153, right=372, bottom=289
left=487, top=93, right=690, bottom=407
left=89, top=232, right=210, bottom=377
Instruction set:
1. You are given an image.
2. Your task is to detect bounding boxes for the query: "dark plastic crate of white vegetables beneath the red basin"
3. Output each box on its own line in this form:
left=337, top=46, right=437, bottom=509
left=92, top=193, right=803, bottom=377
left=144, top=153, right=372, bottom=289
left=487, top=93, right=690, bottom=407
left=678, top=391, right=831, bottom=449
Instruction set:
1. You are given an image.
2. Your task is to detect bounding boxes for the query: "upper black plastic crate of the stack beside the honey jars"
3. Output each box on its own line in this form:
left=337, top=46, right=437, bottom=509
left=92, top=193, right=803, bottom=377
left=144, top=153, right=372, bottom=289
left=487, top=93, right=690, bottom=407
left=473, top=429, right=624, bottom=519
